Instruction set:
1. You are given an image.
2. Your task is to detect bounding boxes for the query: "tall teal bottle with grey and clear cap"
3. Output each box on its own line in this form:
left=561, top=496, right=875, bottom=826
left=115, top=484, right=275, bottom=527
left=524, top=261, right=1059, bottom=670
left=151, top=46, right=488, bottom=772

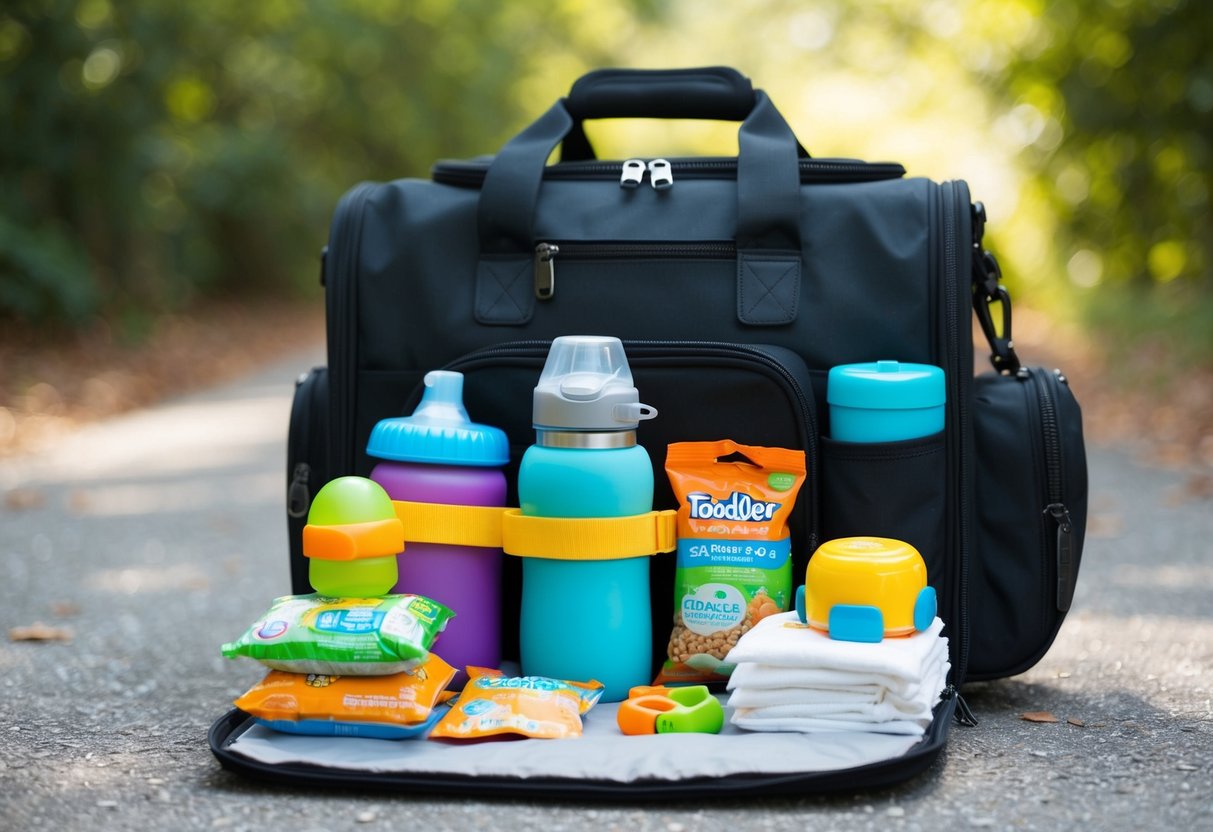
left=518, top=336, right=656, bottom=701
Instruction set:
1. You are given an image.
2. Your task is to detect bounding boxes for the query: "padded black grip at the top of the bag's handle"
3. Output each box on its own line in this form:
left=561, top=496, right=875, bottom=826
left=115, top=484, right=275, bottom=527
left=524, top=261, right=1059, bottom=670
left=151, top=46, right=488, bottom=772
left=560, top=67, right=809, bottom=161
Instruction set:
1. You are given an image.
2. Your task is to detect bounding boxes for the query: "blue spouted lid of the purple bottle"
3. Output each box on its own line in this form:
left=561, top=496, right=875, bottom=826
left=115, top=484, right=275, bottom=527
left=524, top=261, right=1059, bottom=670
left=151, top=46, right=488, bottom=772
left=366, top=370, right=509, bottom=467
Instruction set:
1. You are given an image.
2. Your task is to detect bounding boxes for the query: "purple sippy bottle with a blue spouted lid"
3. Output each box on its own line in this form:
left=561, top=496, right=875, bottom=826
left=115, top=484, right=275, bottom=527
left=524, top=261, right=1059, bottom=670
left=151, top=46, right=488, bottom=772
left=366, top=370, right=509, bottom=671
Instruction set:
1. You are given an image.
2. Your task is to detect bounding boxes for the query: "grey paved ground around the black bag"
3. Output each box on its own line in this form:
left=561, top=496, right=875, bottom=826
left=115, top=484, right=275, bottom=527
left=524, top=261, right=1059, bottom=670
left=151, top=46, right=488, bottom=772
left=0, top=354, right=1213, bottom=832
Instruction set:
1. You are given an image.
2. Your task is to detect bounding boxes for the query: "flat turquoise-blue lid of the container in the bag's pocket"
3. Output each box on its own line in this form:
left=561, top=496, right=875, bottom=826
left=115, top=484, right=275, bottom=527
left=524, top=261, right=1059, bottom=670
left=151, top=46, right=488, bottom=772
left=826, top=361, right=947, bottom=410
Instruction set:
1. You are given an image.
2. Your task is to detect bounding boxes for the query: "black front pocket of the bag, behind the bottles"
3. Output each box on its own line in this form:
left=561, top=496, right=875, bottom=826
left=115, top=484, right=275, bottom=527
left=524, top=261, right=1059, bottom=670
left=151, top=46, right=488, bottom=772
left=422, top=340, right=819, bottom=674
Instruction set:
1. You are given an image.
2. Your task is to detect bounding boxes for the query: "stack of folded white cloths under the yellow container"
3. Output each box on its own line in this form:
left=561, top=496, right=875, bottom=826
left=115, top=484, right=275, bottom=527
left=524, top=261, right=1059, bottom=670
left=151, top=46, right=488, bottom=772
left=724, top=612, right=950, bottom=736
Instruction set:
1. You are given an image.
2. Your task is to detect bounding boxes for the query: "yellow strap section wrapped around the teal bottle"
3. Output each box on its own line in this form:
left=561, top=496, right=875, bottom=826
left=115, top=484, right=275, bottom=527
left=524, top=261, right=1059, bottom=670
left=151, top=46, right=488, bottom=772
left=502, top=508, right=677, bottom=560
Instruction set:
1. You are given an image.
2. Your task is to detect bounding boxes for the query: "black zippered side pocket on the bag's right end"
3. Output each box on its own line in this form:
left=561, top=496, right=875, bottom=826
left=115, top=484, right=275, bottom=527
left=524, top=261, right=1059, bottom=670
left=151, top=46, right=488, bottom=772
left=968, top=367, right=1087, bottom=680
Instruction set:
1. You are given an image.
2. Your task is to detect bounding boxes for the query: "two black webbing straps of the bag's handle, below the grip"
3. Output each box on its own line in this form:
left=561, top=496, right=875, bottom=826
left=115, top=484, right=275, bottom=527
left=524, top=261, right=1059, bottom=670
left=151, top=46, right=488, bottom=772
left=475, top=68, right=801, bottom=326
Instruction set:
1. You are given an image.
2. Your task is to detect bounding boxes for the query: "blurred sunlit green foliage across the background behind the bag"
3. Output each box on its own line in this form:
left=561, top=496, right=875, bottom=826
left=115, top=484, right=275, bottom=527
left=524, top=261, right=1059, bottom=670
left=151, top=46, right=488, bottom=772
left=0, top=0, right=1213, bottom=361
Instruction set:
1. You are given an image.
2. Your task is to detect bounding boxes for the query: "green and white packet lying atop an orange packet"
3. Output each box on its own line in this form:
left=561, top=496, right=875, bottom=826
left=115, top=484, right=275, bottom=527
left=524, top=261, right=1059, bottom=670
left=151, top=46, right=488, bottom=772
left=222, top=594, right=455, bottom=676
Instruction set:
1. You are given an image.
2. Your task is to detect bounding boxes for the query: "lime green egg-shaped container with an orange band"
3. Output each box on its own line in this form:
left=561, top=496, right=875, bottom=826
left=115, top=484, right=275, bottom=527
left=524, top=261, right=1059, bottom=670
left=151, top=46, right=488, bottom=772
left=303, top=477, right=404, bottom=598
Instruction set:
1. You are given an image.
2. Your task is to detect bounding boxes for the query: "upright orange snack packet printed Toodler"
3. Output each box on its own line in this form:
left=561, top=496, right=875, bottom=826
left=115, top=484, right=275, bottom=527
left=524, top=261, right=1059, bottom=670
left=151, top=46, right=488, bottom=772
left=656, top=439, right=805, bottom=684
